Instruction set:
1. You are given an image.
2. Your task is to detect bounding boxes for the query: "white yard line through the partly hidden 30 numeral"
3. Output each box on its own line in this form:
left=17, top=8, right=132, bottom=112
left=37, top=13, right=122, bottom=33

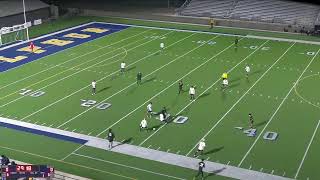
left=139, top=41, right=269, bottom=147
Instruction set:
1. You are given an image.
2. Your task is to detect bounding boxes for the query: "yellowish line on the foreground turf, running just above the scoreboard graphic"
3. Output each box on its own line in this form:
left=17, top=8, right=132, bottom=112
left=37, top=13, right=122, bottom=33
left=0, top=145, right=136, bottom=180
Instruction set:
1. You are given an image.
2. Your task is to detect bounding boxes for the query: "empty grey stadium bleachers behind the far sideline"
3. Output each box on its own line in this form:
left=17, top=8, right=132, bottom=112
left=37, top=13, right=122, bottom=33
left=180, top=0, right=320, bottom=26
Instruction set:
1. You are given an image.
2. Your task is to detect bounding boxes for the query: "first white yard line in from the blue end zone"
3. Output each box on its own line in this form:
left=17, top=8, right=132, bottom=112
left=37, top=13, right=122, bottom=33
left=0, top=30, right=150, bottom=90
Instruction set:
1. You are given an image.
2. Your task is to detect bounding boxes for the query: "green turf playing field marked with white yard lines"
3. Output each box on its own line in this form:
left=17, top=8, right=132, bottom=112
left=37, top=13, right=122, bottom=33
left=0, top=18, right=320, bottom=180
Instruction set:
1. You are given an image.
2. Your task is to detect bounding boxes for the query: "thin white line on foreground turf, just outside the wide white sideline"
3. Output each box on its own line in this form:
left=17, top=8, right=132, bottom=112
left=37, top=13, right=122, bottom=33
left=73, top=153, right=184, bottom=180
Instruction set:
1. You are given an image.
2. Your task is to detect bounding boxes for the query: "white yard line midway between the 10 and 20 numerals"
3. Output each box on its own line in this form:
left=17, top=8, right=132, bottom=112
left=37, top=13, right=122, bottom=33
left=17, top=29, right=176, bottom=120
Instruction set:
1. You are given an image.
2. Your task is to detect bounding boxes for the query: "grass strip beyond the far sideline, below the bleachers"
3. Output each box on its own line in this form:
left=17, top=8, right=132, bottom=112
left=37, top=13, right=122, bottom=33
left=30, top=16, right=320, bottom=41
